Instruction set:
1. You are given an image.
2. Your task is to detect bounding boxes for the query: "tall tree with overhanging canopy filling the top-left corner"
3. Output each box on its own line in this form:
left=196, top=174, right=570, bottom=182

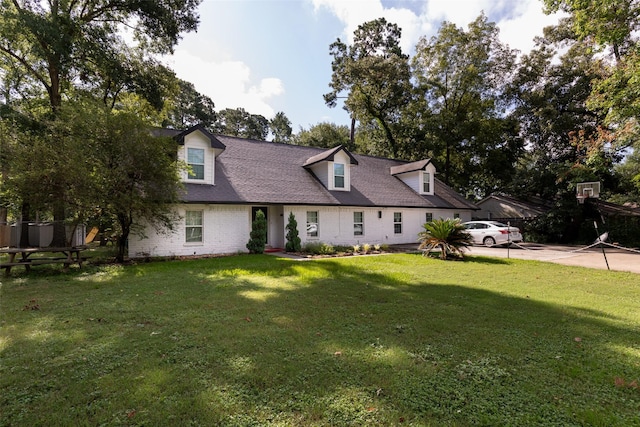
left=0, top=0, right=200, bottom=245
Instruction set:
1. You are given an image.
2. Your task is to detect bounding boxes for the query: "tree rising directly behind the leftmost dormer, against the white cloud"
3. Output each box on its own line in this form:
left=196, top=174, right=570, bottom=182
left=162, top=80, right=216, bottom=129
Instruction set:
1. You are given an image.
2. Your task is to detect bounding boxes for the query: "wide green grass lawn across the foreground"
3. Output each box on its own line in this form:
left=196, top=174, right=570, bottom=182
left=0, top=254, right=640, bottom=426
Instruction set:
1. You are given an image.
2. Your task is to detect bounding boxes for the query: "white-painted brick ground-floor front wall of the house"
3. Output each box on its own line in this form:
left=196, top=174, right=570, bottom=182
left=129, top=205, right=471, bottom=258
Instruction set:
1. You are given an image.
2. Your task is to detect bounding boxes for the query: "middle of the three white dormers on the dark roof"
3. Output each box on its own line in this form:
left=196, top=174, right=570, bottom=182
left=302, top=145, right=358, bottom=191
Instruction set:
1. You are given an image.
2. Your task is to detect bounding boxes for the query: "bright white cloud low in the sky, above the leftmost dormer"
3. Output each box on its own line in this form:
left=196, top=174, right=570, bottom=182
left=165, top=49, right=284, bottom=118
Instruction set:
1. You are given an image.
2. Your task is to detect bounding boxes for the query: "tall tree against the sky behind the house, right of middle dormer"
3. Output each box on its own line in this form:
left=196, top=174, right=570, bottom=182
left=324, top=18, right=411, bottom=157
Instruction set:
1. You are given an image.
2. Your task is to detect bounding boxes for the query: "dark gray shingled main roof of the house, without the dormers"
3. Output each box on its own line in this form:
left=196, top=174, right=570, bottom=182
left=184, top=135, right=478, bottom=210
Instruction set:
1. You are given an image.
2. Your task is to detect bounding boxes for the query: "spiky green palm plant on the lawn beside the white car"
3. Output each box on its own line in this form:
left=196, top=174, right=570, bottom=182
left=418, top=218, right=473, bottom=260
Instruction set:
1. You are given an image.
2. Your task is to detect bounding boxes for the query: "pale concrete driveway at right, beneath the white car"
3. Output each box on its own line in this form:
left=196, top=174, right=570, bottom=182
left=468, top=243, right=640, bottom=274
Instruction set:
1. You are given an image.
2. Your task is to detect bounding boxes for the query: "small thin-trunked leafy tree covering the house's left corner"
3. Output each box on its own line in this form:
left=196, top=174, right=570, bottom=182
left=95, top=109, right=182, bottom=261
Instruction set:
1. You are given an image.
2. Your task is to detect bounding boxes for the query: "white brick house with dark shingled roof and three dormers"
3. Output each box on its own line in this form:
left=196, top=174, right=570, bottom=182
left=129, top=126, right=477, bottom=257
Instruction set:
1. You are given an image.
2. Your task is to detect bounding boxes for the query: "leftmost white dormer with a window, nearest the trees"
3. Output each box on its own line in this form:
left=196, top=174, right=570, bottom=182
left=174, top=125, right=226, bottom=185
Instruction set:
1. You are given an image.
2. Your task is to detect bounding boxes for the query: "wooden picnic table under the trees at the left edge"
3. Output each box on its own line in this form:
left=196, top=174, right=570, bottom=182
left=0, top=246, right=87, bottom=276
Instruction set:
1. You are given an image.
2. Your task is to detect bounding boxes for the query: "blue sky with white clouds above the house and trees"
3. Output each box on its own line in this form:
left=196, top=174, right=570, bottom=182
left=165, top=0, right=558, bottom=133
